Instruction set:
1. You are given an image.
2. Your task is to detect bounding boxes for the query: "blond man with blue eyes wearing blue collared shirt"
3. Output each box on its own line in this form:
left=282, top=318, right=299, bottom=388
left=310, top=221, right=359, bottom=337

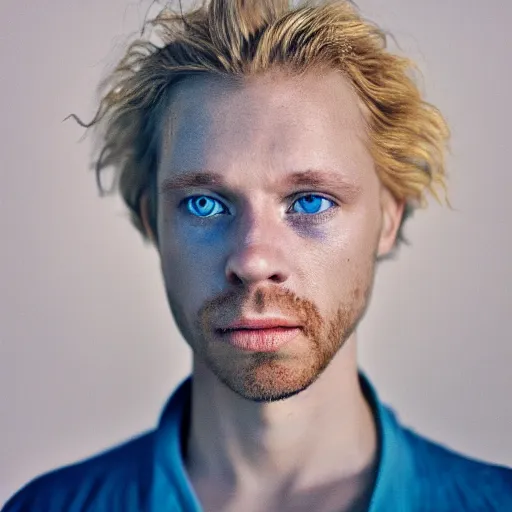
left=4, top=0, right=512, bottom=512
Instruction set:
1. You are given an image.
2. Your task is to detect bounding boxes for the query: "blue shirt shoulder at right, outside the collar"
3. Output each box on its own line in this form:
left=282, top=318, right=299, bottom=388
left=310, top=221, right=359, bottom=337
left=402, top=418, right=512, bottom=511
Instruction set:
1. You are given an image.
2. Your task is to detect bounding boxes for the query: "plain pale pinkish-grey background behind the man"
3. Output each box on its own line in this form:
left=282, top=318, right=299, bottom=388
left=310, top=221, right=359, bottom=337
left=0, top=0, right=512, bottom=503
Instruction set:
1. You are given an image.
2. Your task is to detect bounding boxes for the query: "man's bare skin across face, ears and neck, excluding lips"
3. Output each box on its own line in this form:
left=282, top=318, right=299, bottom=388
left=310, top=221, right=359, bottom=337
left=142, top=71, right=403, bottom=511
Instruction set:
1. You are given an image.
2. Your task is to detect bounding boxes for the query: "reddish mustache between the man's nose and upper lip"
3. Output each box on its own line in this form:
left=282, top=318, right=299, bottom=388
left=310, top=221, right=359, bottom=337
left=198, top=287, right=323, bottom=333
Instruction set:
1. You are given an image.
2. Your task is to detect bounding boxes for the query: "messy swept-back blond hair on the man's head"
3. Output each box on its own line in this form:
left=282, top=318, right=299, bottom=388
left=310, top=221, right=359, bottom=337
left=74, top=0, right=449, bottom=250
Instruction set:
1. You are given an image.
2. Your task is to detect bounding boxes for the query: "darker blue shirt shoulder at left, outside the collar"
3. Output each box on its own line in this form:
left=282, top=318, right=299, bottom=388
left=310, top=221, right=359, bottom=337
left=2, top=432, right=154, bottom=512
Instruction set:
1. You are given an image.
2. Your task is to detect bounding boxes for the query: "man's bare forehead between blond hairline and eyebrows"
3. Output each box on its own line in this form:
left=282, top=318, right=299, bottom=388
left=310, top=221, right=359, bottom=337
left=161, top=71, right=373, bottom=183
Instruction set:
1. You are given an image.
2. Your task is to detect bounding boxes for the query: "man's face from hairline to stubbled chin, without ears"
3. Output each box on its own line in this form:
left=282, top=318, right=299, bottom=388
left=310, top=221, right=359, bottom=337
left=154, top=72, right=394, bottom=401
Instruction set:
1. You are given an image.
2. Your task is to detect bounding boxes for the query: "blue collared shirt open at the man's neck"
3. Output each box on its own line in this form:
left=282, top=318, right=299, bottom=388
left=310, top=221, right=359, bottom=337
left=2, top=374, right=512, bottom=512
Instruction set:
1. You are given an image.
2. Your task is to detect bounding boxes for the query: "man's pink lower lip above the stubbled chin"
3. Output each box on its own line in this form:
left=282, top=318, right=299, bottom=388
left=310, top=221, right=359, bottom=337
left=215, top=327, right=301, bottom=352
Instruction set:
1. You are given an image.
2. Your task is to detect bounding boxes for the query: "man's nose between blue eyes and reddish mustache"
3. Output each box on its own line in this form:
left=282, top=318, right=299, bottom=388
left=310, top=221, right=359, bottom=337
left=226, top=210, right=290, bottom=286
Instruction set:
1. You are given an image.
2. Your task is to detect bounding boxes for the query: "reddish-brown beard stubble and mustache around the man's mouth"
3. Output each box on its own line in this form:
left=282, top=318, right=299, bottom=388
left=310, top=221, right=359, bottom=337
left=193, top=258, right=375, bottom=402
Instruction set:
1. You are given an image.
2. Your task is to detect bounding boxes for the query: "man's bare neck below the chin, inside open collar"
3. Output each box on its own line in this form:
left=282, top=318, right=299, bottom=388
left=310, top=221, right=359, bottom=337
left=185, top=333, right=377, bottom=510
